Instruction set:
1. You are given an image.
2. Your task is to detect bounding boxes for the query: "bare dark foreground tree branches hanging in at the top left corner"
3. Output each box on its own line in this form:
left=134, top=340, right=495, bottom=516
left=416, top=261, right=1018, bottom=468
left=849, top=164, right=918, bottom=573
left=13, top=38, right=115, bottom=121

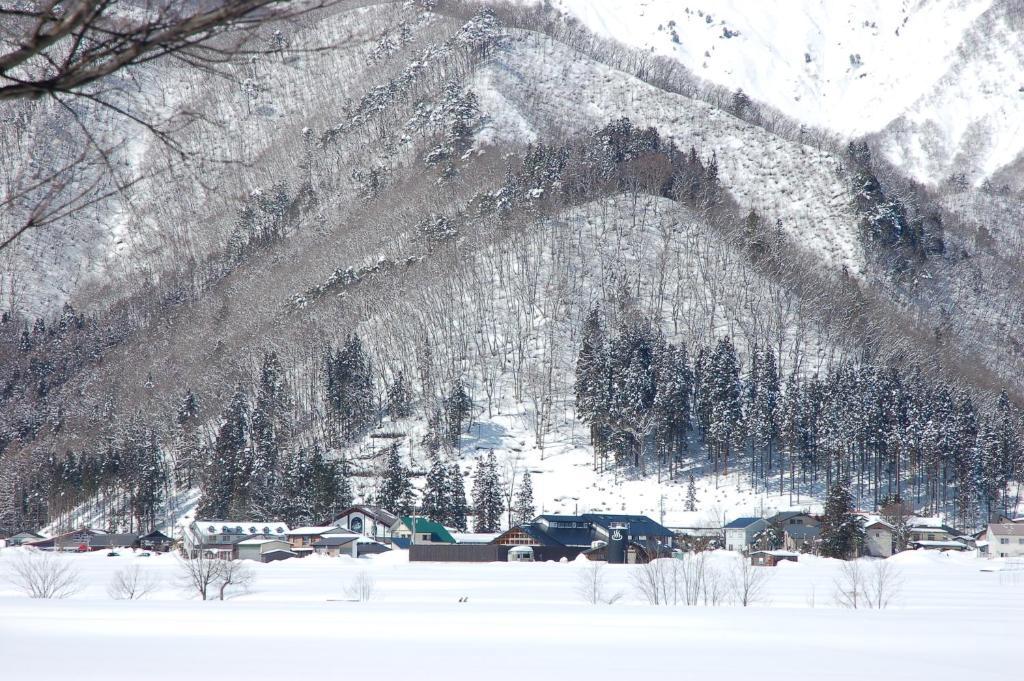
left=0, top=0, right=345, bottom=251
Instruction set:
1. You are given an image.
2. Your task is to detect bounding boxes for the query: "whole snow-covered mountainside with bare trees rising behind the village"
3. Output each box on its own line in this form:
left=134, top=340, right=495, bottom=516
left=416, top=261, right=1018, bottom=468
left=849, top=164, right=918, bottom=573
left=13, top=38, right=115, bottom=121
left=0, top=0, right=1024, bottom=523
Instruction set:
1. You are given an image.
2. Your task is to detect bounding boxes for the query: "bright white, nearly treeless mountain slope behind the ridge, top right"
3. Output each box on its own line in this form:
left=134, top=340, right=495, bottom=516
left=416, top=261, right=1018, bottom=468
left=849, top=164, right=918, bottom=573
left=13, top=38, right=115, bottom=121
left=553, top=0, right=1024, bottom=184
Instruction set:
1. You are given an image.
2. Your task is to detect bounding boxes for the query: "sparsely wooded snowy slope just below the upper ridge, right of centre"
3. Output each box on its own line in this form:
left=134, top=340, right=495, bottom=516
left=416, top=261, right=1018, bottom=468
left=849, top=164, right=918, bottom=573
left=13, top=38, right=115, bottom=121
left=473, top=29, right=864, bottom=274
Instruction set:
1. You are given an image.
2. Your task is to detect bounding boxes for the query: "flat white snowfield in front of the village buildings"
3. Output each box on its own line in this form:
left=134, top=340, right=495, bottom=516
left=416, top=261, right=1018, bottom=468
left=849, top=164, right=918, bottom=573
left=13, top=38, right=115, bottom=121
left=0, top=550, right=1024, bottom=681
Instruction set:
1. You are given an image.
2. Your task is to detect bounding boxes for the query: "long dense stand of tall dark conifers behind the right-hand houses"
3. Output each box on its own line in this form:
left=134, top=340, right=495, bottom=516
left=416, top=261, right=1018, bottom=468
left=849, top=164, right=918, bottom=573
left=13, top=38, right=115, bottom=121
left=575, top=309, right=1024, bottom=527
